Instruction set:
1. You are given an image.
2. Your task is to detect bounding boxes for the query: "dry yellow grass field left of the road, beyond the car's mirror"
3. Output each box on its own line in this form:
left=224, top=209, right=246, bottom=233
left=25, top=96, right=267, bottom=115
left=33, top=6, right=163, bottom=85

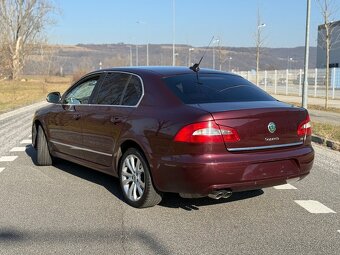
left=0, top=76, right=72, bottom=113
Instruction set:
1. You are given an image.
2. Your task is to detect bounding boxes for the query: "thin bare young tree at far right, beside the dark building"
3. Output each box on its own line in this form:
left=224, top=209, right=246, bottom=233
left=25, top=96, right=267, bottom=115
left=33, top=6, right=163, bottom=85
left=317, top=0, right=340, bottom=109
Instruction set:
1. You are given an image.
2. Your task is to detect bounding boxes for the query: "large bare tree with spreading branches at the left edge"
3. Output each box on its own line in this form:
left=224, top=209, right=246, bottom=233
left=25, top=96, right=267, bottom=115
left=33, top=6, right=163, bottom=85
left=0, top=0, right=55, bottom=79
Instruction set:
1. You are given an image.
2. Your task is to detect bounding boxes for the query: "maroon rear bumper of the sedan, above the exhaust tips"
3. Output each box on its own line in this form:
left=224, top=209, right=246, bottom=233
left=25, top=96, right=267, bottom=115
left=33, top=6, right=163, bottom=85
left=152, top=146, right=314, bottom=195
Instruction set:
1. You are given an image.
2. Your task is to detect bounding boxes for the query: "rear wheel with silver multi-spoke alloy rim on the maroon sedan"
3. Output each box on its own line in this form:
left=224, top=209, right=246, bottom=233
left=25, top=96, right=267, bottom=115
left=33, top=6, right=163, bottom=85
left=119, top=148, right=162, bottom=208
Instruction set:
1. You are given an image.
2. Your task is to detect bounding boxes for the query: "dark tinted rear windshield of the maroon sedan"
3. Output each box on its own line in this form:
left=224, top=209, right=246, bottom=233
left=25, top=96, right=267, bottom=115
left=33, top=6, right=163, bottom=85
left=164, top=73, right=275, bottom=104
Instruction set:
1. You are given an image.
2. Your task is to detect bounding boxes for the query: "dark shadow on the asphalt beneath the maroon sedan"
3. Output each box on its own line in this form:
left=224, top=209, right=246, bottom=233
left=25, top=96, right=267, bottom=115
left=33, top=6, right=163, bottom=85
left=26, top=145, right=264, bottom=211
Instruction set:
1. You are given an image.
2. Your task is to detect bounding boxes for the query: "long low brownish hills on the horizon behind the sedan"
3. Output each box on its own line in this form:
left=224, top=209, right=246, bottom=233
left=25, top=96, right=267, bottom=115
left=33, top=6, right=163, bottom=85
left=23, top=43, right=316, bottom=75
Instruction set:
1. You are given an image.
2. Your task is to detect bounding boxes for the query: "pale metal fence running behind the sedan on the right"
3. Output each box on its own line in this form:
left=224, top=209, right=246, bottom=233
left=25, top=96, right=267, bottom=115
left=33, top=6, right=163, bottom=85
left=238, top=68, right=340, bottom=99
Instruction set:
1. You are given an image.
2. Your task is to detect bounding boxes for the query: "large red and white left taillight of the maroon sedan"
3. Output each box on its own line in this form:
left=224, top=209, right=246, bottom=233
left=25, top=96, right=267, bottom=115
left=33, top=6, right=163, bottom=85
left=174, top=121, right=240, bottom=143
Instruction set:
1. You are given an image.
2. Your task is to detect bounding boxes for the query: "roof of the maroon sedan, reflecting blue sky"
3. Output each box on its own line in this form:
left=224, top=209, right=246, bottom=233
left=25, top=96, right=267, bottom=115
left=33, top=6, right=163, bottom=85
left=91, top=66, right=242, bottom=77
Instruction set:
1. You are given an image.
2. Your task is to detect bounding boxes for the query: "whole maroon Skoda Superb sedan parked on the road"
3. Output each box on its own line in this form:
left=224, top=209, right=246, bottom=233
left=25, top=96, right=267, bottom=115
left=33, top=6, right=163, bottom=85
left=32, top=67, right=314, bottom=207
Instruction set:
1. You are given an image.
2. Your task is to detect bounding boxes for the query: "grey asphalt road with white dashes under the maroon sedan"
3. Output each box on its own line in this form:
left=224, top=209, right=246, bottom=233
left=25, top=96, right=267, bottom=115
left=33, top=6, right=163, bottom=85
left=0, top=102, right=340, bottom=255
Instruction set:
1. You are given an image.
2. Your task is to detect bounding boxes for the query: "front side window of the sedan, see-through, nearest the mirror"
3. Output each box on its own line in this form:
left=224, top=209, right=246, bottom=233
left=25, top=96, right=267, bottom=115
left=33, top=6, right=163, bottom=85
left=65, top=77, right=99, bottom=104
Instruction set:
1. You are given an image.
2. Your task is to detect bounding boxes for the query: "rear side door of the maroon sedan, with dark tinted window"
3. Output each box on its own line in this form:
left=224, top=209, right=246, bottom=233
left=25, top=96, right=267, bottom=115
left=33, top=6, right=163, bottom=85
left=83, top=72, right=143, bottom=167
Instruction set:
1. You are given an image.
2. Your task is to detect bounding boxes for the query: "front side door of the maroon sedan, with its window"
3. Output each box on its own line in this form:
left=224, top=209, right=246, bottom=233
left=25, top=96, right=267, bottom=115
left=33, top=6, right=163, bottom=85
left=49, top=74, right=100, bottom=158
